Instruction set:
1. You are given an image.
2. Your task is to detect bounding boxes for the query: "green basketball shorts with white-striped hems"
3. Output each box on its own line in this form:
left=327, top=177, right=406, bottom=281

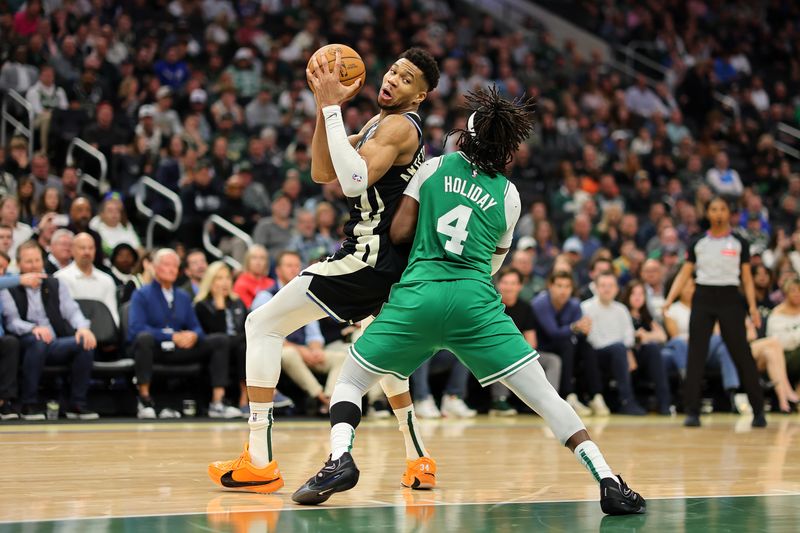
left=350, top=280, right=539, bottom=387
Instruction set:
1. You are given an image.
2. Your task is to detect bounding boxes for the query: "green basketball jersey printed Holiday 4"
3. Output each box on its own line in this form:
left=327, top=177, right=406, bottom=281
left=401, top=152, right=520, bottom=283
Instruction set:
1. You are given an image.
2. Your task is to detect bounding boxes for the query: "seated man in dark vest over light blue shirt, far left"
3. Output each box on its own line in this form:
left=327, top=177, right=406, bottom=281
left=0, top=241, right=98, bottom=420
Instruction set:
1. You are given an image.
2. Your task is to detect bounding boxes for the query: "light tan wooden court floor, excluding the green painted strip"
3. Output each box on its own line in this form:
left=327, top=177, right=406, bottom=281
left=0, top=415, right=800, bottom=526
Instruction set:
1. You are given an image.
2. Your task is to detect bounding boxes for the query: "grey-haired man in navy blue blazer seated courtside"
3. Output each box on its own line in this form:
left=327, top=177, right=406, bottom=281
left=128, top=248, right=242, bottom=418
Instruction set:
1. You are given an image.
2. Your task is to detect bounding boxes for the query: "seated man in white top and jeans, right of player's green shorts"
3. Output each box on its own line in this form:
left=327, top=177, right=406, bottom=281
left=581, top=272, right=647, bottom=416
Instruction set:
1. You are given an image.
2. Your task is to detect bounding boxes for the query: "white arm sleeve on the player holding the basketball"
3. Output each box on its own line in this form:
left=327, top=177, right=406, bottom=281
left=322, top=105, right=369, bottom=198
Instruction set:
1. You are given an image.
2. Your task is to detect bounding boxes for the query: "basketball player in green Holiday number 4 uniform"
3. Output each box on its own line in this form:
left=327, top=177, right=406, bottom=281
left=292, top=88, right=646, bottom=514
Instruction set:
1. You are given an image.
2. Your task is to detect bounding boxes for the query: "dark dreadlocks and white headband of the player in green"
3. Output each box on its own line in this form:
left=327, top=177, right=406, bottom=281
left=448, top=85, right=535, bottom=176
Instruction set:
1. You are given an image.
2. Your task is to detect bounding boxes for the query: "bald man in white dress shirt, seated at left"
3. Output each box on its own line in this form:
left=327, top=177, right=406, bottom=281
left=54, top=233, right=119, bottom=326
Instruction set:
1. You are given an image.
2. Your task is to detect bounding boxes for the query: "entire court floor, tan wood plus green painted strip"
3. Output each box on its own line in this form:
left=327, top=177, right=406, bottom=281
left=0, top=415, right=800, bottom=532
